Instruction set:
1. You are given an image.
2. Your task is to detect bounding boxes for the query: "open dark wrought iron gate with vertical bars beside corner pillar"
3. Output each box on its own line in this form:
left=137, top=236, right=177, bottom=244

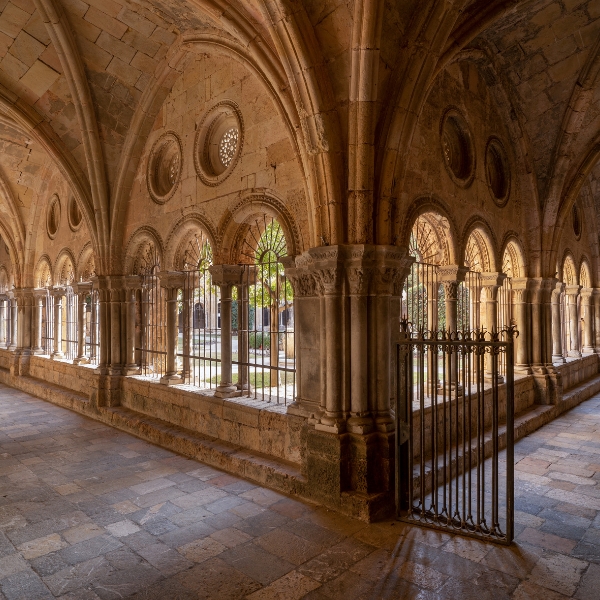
left=396, top=321, right=516, bottom=544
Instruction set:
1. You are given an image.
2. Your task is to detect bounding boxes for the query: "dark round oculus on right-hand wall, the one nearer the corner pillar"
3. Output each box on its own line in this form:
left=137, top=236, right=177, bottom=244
left=440, top=108, right=475, bottom=187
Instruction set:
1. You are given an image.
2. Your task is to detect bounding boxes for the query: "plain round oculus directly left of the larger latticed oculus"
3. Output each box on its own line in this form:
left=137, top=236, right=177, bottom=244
left=147, top=131, right=183, bottom=204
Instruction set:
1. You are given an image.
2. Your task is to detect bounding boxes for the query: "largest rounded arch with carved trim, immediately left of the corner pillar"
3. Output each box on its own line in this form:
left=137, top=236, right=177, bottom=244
left=219, top=194, right=302, bottom=264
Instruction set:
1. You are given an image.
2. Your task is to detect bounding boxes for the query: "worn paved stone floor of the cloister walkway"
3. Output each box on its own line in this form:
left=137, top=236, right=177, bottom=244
left=0, top=386, right=600, bottom=600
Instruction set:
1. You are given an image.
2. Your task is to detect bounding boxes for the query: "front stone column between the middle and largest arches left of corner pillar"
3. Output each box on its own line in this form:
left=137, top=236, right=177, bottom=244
left=209, top=265, right=243, bottom=398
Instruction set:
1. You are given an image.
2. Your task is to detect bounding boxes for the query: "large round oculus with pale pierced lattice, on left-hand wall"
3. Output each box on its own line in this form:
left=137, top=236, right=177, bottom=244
left=194, top=100, right=244, bottom=186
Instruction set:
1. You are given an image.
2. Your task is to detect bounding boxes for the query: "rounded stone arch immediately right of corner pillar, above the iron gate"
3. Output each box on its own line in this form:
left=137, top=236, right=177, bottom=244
left=400, top=196, right=457, bottom=265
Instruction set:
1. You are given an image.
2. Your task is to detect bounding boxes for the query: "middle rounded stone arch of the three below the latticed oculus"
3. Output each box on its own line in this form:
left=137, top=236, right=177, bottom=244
left=165, top=213, right=217, bottom=271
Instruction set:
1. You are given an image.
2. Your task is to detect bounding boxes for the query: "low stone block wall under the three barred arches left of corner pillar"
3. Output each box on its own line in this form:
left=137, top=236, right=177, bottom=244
left=121, top=377, right=305, bottom=465
